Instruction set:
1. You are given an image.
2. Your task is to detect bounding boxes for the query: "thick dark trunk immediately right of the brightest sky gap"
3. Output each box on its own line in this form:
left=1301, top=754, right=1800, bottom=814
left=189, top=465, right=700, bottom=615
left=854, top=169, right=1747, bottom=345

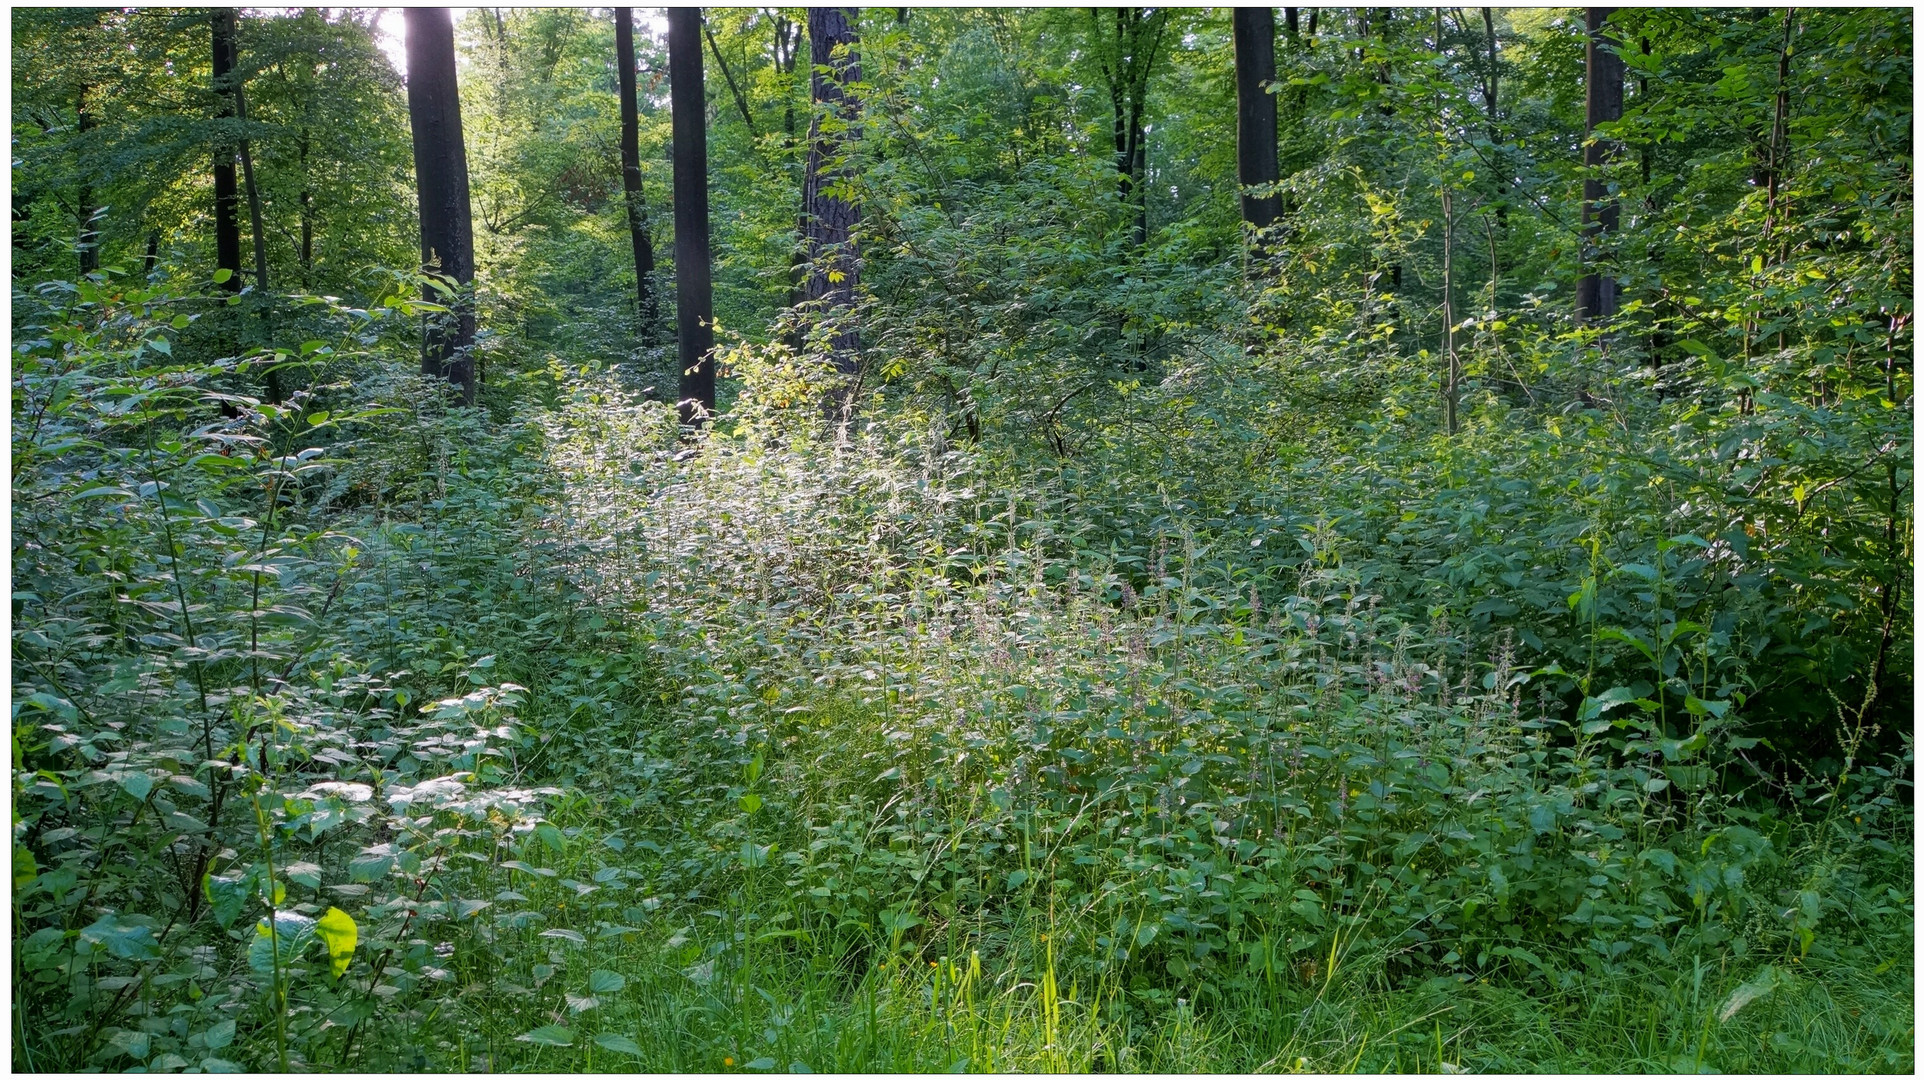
left=406, top=8, right=475, bottom=404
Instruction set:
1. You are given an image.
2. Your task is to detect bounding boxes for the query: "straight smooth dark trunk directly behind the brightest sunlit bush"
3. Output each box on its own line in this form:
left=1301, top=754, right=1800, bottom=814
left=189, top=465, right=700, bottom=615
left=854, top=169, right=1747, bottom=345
left=668, top=8, right=716, bottom=425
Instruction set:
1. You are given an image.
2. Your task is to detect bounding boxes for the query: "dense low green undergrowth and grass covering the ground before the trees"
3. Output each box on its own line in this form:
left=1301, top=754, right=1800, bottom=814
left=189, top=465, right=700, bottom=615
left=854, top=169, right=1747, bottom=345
left=12, top=283, right=1914, bottom=1072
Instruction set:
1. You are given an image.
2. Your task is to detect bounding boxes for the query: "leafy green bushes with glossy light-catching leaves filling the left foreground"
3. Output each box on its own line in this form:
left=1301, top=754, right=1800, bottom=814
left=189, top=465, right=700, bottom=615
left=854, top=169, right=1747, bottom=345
left=12, top=273, right=544, bottom=1070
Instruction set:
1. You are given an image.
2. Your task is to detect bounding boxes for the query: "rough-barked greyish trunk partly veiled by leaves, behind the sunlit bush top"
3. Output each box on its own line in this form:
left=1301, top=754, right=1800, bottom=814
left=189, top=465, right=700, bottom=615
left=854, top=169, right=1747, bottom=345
left=802, top=8, right=862, bottom=412
